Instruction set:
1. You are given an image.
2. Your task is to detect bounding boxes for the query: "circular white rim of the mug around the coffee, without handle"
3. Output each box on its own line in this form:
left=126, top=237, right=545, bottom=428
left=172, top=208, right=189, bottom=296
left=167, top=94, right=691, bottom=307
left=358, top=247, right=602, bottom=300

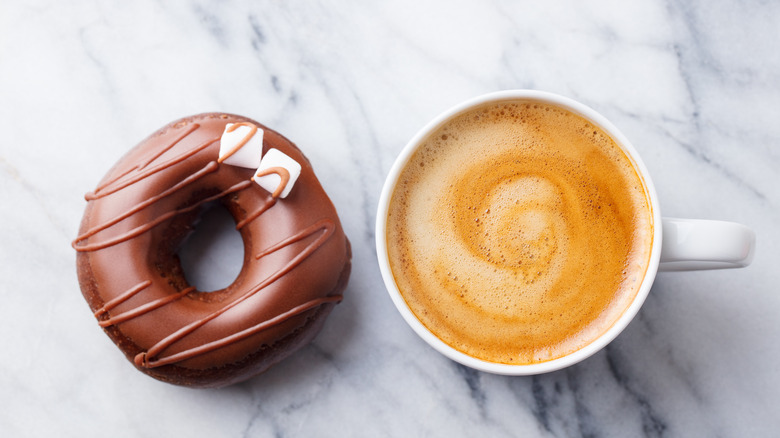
left=375, top=89, right=663, bottom=375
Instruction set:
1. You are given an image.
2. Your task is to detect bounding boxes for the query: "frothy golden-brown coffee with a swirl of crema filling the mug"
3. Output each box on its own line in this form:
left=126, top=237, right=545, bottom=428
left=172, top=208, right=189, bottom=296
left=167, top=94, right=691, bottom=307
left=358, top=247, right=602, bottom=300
left=386, top=101, right=653, bottom=364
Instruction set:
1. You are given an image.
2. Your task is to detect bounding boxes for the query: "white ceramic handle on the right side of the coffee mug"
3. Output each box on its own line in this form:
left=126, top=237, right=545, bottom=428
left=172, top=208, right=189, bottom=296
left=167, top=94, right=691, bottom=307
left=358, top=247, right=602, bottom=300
left=658, top=217, right=756, bottom=271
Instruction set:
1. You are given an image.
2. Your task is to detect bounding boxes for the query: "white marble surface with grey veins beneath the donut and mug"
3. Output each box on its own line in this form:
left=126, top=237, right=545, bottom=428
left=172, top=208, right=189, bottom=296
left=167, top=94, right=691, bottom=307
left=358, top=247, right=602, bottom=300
left=0, top=0, right=780, bottom=437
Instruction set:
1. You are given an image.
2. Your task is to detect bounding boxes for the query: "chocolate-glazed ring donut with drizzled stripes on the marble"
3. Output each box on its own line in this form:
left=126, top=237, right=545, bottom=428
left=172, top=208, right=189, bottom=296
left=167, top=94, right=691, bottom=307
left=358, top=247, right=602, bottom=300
left=72, top=113, right=351, bottom=387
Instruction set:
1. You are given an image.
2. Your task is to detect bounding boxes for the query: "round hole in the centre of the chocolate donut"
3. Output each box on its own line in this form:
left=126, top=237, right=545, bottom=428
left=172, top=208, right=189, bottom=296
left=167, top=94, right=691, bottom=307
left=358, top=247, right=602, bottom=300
left=177, top=202, right=244, bottom=292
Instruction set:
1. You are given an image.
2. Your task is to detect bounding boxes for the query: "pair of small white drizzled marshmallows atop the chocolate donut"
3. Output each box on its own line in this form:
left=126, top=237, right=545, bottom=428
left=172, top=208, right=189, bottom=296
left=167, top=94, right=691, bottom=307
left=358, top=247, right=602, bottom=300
left=218, top=122, right=301, bottom=198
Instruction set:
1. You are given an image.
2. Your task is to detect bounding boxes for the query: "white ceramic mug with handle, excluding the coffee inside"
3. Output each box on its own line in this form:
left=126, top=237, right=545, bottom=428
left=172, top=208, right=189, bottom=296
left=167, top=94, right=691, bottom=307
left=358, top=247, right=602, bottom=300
left=376, top=90, right=755, bottom=375
